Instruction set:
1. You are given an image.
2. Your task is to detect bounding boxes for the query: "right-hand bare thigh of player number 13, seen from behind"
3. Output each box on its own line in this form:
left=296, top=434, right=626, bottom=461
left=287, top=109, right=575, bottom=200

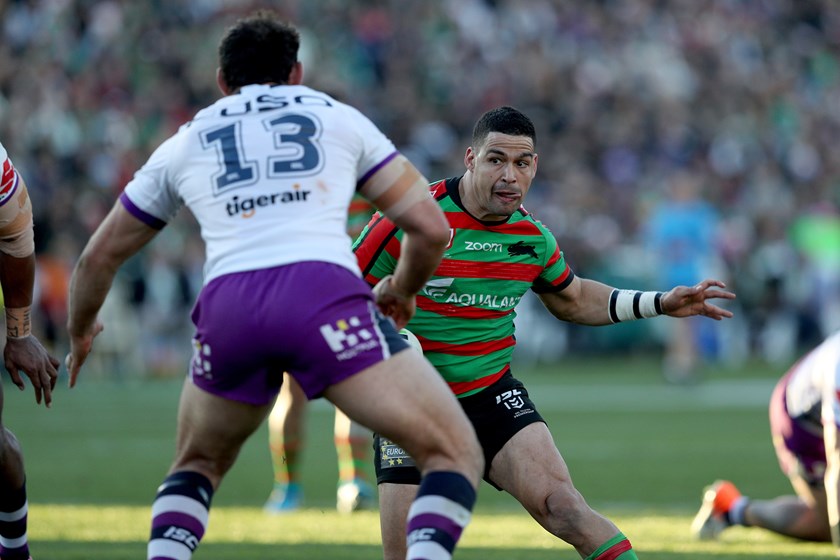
left=324, top=350, right=477, bottom=465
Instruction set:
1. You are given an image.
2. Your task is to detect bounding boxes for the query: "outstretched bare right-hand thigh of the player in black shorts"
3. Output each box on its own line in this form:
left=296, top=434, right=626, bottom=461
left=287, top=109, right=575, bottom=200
left=489, top=422, right=572, bottom=512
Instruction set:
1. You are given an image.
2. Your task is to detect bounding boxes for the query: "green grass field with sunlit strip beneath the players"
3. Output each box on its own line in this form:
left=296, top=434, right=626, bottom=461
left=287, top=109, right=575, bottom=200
left=4, top=356, right=832, bottom=560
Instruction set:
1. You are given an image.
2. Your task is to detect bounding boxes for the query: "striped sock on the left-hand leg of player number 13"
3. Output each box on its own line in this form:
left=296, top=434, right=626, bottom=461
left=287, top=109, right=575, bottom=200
left=147, top=471, right=213, bottom=560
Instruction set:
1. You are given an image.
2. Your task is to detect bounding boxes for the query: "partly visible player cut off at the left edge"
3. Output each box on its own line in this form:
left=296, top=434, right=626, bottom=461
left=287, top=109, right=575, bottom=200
left=0, top=144, right=59, bottom=560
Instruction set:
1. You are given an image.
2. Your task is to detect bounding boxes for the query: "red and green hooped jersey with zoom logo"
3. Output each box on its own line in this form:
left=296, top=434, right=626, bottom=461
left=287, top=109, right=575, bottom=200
left=353, top=177, right=574, bottom=397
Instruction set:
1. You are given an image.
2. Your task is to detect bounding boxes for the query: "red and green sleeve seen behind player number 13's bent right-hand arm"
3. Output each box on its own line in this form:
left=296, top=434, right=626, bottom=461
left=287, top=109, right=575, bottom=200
left=353, top=212, right=402, bottom=286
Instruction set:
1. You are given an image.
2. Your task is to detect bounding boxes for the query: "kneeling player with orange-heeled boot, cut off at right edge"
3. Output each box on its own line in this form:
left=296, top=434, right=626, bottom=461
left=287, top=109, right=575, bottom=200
left=691, top=332, right=840, bottom=557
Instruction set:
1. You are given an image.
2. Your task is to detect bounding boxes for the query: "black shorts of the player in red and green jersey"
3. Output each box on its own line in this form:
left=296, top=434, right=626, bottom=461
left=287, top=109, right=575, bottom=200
left=373, top=370, right=545, bottom=490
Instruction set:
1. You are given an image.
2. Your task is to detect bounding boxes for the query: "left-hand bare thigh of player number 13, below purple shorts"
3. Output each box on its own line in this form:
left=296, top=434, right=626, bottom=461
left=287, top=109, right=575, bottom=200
left=176, top=380, right=271, bottom=474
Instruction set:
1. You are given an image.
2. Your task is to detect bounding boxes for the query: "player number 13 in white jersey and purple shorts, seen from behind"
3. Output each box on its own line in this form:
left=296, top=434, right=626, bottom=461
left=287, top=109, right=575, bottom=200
left=67, top=12, right=483, bottom=560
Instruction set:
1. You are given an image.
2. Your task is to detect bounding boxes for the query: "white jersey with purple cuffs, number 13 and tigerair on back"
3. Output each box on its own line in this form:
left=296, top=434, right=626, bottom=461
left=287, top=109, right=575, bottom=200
left=120, top=85, right=397, bottom=284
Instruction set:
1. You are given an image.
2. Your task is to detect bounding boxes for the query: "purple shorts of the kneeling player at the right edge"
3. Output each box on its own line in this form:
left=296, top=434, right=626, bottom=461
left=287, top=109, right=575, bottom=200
left=770, top=373, right=826, bottom=485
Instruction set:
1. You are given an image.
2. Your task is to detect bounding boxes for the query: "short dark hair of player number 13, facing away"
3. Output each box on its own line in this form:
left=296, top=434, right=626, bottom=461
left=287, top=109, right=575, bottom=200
left=219, top=10, right=300, bottom=91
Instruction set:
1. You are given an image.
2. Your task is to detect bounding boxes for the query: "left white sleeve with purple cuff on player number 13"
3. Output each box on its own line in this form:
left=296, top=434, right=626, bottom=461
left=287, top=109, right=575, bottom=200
left=120, top=137, right=182, bottom=229
